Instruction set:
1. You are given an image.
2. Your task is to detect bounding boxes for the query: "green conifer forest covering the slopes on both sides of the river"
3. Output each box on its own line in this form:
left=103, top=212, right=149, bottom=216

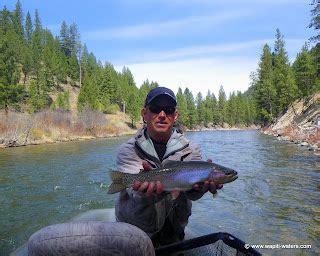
left=0, top=1, right=320, bottom=144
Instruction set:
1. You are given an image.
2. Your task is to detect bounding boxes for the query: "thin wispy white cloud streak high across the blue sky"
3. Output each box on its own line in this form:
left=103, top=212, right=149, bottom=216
left=84, top=10, right=248, bottom=40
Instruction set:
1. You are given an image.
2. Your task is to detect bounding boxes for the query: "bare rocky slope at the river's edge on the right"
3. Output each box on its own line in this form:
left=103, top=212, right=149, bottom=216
left=262, top=93, right=320, bottom=151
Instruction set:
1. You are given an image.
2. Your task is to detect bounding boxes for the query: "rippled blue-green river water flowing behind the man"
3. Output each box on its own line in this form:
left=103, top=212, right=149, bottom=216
left=0, top=130, right=320, bottom=255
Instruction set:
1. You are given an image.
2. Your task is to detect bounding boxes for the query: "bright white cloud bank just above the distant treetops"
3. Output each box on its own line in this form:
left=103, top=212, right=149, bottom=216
left=115, top=57, right=257, bottom=96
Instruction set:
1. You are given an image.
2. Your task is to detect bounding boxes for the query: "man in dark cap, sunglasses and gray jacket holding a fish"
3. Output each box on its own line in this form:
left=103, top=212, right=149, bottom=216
left=116, top=87, right=222, bottom=247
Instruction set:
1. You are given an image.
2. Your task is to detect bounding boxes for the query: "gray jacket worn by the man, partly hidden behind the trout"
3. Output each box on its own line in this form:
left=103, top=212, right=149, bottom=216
left=115, top=128, right=203, bottom=238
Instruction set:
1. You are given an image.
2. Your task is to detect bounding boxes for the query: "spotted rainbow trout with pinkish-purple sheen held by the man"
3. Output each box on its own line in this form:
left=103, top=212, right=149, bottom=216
left=108, top=161, right=238, bottom=194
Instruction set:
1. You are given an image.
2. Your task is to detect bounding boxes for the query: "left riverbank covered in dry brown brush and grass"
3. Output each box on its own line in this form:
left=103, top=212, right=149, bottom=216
left=0, top=110, right=136, bottom=148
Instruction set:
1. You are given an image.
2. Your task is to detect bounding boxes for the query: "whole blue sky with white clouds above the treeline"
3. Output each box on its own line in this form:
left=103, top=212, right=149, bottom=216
left=0, top=0, right=315, bottom=96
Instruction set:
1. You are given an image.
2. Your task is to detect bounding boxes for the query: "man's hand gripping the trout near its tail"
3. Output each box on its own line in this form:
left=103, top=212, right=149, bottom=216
left=132, top=160, right=163, bottom=196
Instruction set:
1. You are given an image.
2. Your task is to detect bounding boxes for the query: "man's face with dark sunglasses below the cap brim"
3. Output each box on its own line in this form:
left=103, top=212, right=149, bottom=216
left=141, top=96, right=178, bottom=140
